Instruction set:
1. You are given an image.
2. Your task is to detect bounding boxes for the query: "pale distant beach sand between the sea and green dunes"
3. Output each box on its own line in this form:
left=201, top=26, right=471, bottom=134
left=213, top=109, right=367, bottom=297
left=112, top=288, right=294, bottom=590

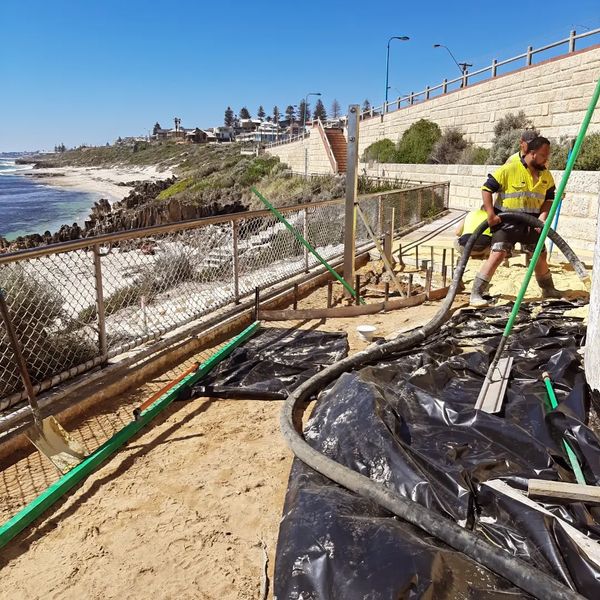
left=24, top=166, right=173, bottom=201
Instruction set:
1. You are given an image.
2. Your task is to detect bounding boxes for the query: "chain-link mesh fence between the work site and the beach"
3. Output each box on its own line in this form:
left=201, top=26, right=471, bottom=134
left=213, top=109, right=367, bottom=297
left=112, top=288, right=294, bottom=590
left=0, top=183, right=449, bottom=410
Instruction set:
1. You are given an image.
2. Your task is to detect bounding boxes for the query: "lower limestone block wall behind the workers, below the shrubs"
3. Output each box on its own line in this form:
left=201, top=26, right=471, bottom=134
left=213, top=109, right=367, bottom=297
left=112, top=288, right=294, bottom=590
left=359, top=163, right=600, bottom=251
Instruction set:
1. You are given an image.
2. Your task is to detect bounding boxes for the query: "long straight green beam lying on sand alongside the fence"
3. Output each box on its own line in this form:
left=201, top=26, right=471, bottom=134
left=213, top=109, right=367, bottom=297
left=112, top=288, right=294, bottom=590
left=0, top=321, right=260, bottom=548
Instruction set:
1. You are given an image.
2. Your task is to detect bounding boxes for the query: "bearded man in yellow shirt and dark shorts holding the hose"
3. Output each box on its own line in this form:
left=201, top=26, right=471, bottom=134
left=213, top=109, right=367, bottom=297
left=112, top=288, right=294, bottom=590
left=470, top=136, right=563, bottom=306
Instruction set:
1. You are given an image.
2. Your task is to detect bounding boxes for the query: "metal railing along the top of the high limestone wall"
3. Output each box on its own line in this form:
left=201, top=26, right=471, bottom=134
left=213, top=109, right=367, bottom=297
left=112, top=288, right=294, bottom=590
left=360, top=28, right=600, bottom=119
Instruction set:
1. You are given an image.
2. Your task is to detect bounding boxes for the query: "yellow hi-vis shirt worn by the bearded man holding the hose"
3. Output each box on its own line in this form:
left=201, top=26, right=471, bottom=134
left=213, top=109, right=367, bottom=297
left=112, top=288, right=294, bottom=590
left=481, top=160, right=555, bottom=216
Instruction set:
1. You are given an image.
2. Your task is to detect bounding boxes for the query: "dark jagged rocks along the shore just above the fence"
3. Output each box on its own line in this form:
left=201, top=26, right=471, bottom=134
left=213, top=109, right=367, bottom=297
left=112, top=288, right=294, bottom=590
left=0, top=177, right=248, bottom=253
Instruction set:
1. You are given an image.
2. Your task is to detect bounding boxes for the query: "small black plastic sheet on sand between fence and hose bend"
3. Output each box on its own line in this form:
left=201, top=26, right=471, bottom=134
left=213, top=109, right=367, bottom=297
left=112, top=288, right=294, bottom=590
left=191, top=327, right=348, bottom=400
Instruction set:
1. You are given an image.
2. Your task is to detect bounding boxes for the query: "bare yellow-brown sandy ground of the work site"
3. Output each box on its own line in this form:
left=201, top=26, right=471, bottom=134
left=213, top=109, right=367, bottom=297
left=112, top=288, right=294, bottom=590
left=0, top=213, right=584, bottom=600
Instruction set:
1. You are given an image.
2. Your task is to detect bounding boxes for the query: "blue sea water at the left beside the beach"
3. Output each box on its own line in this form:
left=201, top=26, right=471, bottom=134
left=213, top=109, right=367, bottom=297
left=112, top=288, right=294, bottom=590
left=0, top=158, right=101, bottom=240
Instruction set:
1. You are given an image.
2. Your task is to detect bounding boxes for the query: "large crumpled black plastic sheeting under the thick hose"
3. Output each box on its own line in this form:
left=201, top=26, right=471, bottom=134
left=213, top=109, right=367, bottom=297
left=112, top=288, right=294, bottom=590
left=275, top=302, right=600, bottom=600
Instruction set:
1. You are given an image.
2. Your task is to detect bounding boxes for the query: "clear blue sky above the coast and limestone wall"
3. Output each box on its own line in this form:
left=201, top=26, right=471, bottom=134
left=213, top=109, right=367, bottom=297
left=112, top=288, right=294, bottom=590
left=0, top=0, right=600, bottom=151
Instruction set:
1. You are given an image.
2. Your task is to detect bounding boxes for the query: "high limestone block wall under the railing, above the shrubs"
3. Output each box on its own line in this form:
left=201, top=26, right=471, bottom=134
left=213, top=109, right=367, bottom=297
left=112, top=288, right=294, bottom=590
left=359, top=46, right=600, bottom=155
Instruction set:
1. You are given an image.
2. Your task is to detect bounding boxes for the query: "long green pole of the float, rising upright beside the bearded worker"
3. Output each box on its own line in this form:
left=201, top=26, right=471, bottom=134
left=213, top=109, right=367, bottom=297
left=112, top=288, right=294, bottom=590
left=483, top=79, right=600, bottom=396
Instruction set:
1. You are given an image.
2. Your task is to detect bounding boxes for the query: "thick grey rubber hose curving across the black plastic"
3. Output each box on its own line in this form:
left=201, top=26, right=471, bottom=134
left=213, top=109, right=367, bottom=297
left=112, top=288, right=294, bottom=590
left=280, top=213, right=586, bottom=600
